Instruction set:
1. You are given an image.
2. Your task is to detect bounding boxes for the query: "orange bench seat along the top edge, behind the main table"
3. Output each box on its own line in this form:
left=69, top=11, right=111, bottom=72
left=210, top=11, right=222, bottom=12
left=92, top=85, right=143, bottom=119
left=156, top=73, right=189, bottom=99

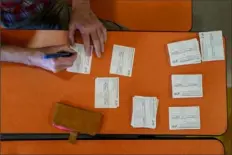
left=69, top=0, right=192, bottom=31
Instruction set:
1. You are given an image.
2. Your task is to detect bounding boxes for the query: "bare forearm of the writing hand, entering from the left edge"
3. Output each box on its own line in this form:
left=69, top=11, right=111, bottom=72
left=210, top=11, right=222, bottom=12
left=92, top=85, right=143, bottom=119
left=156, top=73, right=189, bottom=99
left=1, top=46, right=36, bottom=65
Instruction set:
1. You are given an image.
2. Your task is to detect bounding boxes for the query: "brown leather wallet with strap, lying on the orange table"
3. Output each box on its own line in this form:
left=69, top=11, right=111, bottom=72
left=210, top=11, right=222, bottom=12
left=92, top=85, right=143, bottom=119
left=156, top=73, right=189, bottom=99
left=53, top=103, right=102, bottom=141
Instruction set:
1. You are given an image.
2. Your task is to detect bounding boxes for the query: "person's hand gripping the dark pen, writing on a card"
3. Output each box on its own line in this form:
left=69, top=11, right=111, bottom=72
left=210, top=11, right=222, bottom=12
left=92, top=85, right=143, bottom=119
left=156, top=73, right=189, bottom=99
left=30, top=45, right=77, bottom=73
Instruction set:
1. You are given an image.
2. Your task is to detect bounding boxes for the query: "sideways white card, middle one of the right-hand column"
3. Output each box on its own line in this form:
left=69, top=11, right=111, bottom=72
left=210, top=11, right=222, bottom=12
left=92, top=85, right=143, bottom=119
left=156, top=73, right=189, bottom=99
left=172, top=74, right=203, bottom=98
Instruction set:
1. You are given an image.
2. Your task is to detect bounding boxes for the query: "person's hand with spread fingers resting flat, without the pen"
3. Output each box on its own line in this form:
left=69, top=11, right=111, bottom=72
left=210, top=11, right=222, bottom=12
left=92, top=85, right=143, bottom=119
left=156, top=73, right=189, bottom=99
left=69, top=6, right=107, bottom=57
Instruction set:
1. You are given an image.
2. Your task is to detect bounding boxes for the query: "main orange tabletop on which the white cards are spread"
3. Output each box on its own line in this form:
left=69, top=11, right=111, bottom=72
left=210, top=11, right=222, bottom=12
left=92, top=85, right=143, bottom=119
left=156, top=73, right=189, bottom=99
left=1, top=30, right=227, bottom=135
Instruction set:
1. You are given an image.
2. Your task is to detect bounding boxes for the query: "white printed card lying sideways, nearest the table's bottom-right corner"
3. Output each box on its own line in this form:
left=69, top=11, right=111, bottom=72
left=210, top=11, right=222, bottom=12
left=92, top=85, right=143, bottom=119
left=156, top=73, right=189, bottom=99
left=169, top=106, right=201, bottom=130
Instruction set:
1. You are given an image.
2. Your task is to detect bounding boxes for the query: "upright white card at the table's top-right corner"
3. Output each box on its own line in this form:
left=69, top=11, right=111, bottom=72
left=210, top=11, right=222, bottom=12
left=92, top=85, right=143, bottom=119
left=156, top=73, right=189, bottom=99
left=199, top=31, right=225, bottom=61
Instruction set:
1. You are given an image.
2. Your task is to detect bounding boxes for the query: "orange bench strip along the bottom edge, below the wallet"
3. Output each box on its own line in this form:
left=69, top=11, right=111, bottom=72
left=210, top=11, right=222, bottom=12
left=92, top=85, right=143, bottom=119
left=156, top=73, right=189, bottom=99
left=1, top=140, right=224, bottom=155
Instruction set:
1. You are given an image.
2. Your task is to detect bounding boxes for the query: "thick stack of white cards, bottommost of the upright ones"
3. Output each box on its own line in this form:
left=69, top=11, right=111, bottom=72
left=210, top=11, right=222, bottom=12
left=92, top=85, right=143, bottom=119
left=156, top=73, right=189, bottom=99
left=131, top=96, right=159, bottom=129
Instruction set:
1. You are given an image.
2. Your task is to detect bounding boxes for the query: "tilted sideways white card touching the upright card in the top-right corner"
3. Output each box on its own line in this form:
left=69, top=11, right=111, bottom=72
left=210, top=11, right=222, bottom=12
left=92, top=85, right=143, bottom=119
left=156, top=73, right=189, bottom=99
left=168, top=39, right=201, bottom=66
